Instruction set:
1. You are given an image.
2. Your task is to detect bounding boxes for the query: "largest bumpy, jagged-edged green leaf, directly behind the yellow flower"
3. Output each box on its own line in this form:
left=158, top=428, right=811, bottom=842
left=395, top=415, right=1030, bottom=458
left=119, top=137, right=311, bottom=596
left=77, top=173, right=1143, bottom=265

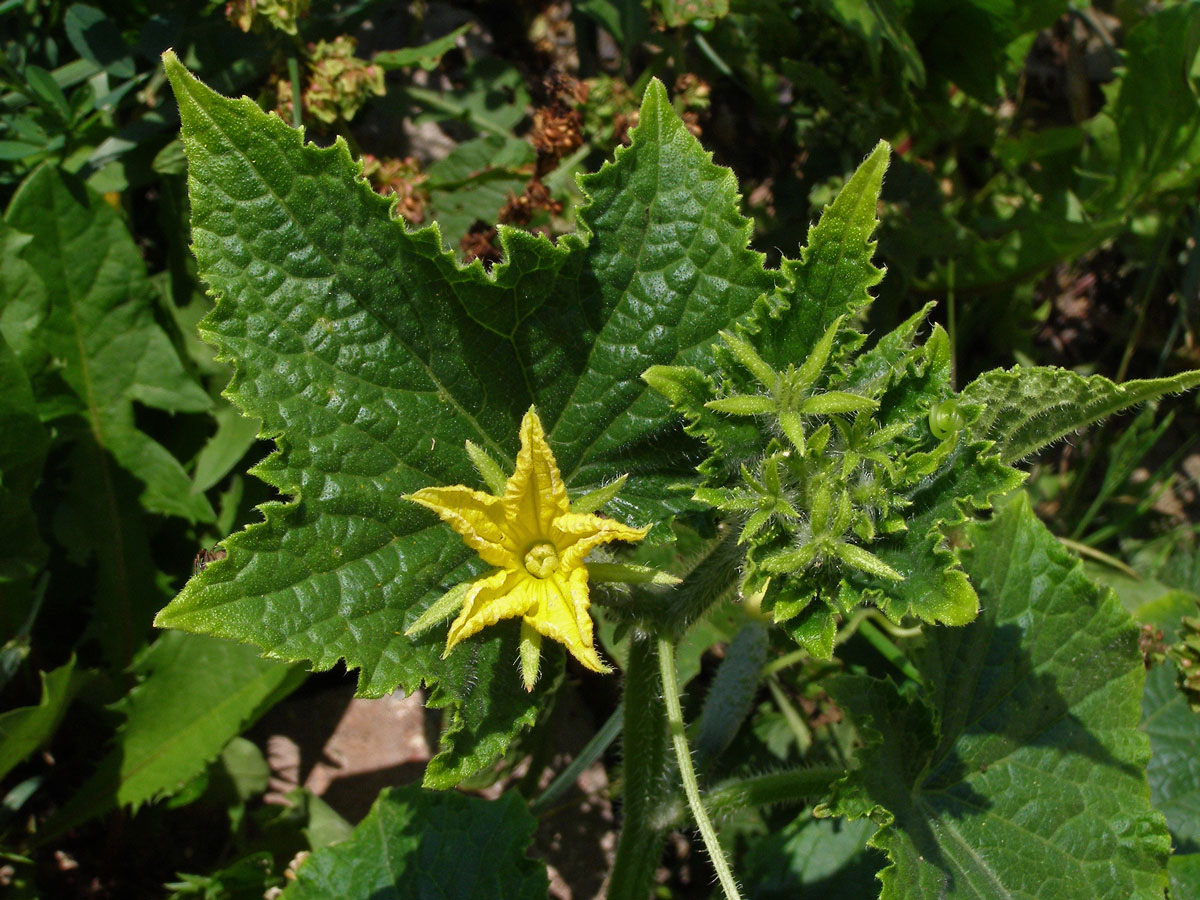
left=158, top=55, right=773, bottom=772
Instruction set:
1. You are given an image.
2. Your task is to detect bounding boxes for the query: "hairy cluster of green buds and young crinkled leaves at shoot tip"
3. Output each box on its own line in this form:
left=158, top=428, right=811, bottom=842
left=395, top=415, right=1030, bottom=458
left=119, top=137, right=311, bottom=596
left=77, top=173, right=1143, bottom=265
left=644, top=144, right=1020, bottom=656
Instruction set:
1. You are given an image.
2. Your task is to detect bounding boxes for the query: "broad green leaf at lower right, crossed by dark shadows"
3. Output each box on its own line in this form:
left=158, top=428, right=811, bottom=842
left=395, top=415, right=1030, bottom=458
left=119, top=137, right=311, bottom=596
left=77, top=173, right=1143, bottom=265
left=832, top=494, right=1170, bottom=900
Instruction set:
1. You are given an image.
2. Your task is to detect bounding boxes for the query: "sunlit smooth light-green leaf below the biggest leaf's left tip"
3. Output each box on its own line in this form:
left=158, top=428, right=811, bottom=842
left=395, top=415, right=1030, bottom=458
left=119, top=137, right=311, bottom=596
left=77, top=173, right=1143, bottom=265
left=48, top=631, right=305, bottom=833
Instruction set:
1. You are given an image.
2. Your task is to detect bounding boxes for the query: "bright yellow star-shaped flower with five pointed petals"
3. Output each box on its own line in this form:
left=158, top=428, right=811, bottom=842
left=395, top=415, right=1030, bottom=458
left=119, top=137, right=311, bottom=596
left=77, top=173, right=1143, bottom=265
left=407, top=408, right=648, bottom=690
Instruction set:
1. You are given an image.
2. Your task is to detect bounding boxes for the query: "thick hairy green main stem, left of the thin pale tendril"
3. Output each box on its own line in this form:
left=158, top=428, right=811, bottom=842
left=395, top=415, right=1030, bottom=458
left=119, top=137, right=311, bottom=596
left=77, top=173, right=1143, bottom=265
left=608, top=631, right=667, bottom=900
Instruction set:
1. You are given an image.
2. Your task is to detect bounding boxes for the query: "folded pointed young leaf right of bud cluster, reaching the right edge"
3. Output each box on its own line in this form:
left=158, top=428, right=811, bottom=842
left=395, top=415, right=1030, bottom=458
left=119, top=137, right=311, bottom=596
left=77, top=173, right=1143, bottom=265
left=960, top=367, right=1200, bottom=463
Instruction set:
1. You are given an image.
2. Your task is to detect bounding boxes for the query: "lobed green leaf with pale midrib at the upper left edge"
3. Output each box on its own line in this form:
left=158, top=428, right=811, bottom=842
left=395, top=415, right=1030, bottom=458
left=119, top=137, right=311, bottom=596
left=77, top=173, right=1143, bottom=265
left=0, top=166, right=214, bottom=521
